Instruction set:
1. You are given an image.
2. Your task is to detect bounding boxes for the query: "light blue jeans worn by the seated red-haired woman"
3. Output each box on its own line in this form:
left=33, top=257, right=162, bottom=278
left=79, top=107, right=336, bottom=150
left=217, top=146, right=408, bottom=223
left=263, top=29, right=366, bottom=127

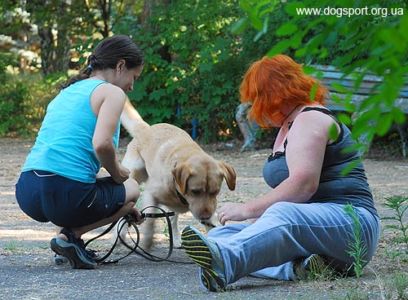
left=208, top=202, right=380, bottom=284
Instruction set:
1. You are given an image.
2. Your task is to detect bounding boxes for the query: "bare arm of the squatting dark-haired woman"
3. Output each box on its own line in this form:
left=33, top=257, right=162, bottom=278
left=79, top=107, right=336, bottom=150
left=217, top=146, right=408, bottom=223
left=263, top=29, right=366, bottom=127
left=92, top=85, right=129, bottom=183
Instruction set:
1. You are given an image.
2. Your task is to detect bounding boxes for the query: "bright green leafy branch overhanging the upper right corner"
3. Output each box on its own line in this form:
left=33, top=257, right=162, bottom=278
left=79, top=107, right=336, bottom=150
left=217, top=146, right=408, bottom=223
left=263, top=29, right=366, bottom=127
left=237, top=0, right=408, bottom=149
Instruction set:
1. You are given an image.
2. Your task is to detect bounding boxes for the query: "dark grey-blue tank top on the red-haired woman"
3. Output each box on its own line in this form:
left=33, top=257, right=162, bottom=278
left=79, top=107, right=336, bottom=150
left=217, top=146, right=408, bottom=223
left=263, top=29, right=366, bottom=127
left=263, top=107, right=377, bottom=215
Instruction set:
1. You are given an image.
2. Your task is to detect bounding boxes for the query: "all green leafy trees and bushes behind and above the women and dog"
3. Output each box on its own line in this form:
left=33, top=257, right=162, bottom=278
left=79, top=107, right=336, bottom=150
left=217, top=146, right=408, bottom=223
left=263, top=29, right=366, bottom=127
left=0, top=0, right=408, bottom=142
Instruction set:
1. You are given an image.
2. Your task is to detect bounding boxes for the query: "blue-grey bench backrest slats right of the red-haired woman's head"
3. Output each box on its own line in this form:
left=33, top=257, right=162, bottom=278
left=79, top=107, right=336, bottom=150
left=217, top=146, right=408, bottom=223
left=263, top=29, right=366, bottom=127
left=313, top=65, right=408, bottom=157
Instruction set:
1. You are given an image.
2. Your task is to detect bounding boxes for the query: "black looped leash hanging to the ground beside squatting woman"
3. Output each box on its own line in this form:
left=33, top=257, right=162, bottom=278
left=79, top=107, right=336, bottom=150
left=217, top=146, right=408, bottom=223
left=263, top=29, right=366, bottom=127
left=85, top=206, right=177, bottom=264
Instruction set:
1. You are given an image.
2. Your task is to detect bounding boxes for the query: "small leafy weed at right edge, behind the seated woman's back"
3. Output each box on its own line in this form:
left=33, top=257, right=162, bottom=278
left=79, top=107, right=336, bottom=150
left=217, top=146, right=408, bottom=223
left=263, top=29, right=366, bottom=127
left=382, top=196, right=408, bottom=254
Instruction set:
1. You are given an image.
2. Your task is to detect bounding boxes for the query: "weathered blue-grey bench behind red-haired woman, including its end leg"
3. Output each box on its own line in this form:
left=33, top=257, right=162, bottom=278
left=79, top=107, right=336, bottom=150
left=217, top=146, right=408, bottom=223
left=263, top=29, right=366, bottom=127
left=235, top=65, right=408, bottom=157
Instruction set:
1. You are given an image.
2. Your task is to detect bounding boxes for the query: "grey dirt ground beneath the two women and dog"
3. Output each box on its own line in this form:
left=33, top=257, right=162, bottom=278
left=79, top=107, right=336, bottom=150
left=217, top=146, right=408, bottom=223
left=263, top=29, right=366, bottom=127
left=0, top=139, right=408, bottom=299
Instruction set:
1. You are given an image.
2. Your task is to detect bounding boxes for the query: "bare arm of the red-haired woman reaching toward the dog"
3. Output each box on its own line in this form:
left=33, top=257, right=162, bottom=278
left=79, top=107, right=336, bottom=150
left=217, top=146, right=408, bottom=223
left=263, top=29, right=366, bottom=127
left=218, top=111, right=333, bottom=224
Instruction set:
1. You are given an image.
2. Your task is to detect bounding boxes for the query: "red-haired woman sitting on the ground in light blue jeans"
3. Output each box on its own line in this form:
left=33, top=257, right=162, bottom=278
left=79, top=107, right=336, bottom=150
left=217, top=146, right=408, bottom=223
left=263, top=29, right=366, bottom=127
left=182, top=55, right=380, bottom=291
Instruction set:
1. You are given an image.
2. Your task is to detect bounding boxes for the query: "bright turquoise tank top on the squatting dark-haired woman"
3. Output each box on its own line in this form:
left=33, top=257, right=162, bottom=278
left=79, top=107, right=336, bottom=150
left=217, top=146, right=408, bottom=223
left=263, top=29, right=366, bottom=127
left=22, top=79, right=120, bottom=183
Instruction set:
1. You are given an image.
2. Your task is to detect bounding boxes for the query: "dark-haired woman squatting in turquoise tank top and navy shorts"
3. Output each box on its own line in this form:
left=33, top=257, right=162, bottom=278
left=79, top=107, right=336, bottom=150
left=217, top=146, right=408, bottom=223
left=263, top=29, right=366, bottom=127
left=16, top=35, right=143, bottom=269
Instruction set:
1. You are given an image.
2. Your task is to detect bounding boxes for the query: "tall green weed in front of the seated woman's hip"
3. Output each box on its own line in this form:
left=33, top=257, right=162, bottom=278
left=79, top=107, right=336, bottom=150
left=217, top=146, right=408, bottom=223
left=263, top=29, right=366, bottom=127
left=344, top=204, right=367, bottom=277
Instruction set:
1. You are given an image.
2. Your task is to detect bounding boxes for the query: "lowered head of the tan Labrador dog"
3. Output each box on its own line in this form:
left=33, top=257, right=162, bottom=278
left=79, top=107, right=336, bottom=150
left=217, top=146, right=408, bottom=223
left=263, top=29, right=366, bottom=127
left=173, top=156, right=236, bottom=222
